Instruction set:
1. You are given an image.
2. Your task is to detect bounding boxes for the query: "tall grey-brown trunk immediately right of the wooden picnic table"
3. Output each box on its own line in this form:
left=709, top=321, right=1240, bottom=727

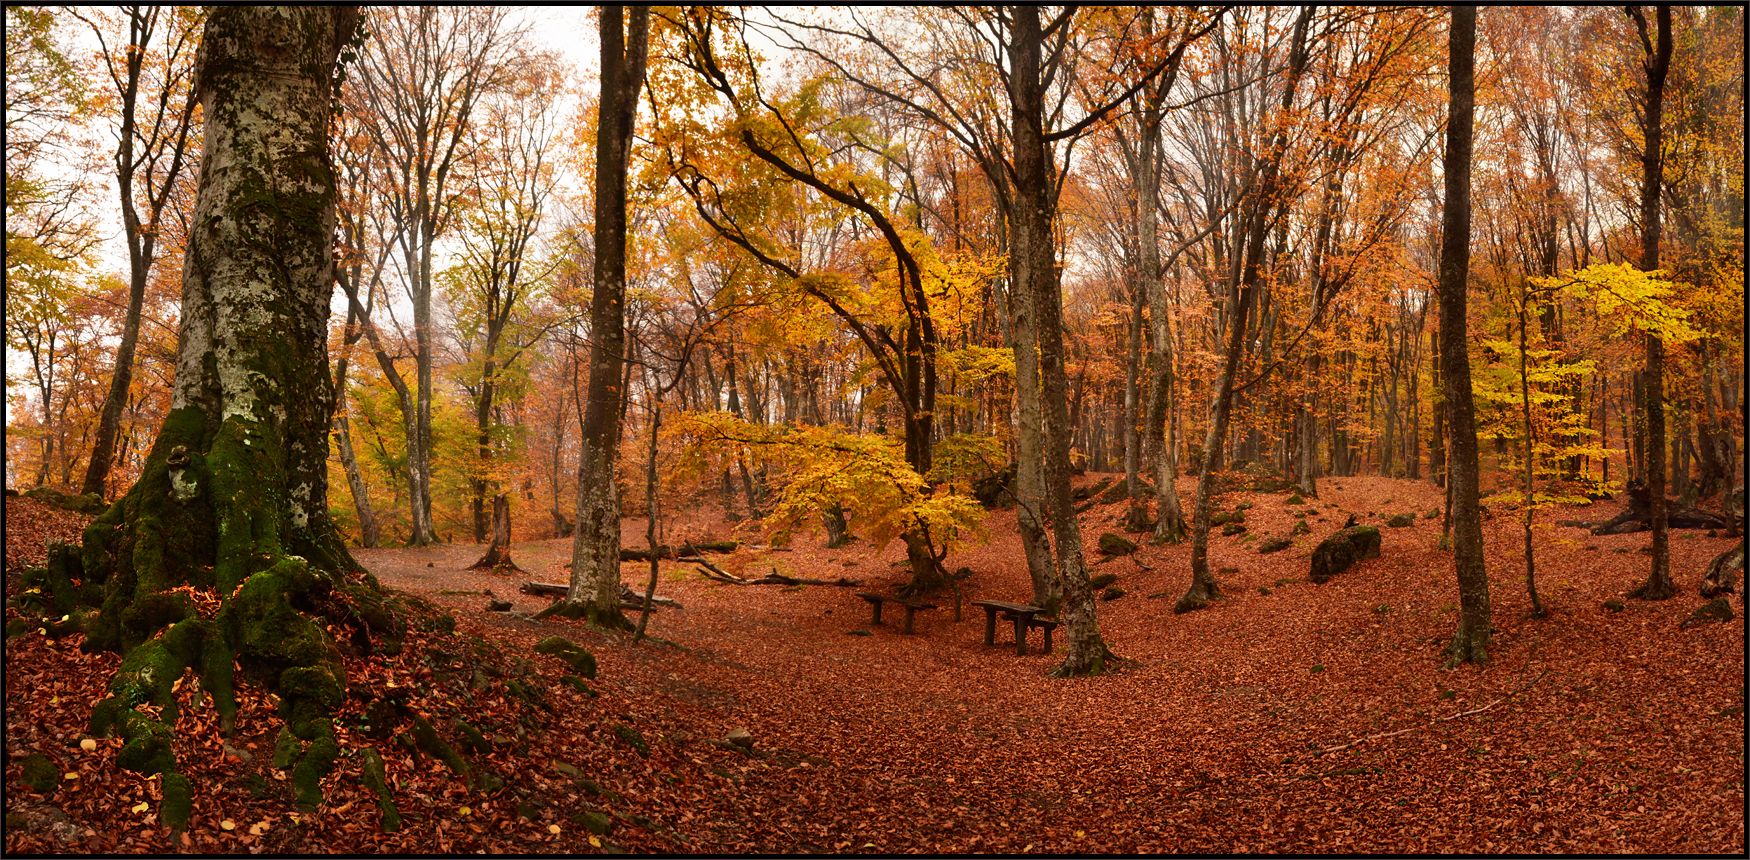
left=1008, top=5, right=1111, bottom=676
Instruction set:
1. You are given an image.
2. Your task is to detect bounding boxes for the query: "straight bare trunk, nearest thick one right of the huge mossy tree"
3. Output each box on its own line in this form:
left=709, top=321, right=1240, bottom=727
left=553, top=5, right=649, bottom=631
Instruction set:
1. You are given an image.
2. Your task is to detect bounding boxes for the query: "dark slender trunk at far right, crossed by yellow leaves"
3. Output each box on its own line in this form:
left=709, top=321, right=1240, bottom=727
left=1629, top=4, right=1677, bottom=601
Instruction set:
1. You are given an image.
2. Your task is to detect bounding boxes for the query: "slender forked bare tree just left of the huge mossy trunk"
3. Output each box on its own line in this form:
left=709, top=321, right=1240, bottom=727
left=74, top=5, right=201, bottom=496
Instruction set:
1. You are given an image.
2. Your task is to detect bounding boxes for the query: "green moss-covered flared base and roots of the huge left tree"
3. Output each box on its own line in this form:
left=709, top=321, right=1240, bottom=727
left=62, top=408, right=403, bottom=830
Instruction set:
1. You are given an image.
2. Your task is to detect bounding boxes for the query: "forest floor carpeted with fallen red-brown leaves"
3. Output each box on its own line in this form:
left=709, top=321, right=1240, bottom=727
left=5, top=478, right=1745, bottom=855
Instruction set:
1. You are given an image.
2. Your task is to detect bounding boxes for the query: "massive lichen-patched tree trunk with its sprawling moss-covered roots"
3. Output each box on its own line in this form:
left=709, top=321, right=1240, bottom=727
left=29, top=5, right=392, bottom=828
